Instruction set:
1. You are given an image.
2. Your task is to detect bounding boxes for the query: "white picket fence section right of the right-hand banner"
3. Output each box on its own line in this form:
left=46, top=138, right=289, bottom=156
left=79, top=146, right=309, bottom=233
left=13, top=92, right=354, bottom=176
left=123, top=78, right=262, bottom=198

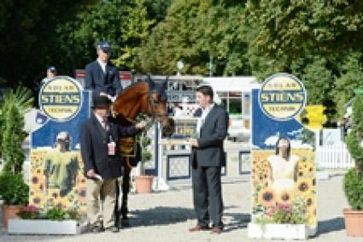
left=315, top=143, right=355, bottom=169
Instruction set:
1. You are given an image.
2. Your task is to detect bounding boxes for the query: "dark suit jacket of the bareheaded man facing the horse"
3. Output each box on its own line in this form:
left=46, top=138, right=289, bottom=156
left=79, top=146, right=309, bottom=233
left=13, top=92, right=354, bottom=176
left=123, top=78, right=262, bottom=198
left=191, top=104, right=228, bottom=167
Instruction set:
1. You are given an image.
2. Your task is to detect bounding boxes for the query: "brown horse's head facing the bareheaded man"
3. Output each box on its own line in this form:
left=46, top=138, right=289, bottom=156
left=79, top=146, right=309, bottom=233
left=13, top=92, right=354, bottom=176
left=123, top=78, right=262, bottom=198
left=146, top=76, right=175, bottom=136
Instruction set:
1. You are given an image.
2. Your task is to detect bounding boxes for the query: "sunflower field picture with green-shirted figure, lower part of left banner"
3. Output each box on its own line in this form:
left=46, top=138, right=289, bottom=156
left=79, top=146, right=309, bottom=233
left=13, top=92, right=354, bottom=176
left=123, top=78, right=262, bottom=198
left=29, top=149, right=86, bottom=214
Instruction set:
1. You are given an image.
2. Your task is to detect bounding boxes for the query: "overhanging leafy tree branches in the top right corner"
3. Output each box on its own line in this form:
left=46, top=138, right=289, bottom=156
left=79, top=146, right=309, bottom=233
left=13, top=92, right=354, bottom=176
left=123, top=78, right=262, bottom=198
left=245, top=0, right=363, bottom=64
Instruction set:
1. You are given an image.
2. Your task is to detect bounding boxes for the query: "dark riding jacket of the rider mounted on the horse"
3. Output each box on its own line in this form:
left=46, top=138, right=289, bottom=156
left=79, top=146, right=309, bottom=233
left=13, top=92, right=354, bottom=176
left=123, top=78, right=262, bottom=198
left=85, top=60, right=122, bottom=96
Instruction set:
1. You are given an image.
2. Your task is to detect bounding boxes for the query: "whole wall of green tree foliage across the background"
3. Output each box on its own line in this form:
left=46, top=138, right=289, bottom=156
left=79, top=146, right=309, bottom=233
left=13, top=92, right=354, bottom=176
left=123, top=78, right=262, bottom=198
left=0, top=0, right=363, bottom=126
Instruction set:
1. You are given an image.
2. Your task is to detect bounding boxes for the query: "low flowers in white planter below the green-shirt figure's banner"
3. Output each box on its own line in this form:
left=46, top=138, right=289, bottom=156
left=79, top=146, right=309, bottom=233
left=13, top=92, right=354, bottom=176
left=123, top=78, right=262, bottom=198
left=17, top=205, right=80, bottom=221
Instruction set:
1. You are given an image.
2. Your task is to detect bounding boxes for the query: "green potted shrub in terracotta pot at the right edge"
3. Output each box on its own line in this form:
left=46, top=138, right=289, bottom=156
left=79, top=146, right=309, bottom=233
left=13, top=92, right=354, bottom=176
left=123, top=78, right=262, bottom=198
left=343, top=89, right=363, bottom=237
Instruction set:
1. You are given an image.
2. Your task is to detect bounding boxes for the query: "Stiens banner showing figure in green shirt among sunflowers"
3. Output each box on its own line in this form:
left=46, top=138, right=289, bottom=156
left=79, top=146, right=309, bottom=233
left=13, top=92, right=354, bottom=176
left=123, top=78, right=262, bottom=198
left=29, top=76, right=91, bottom=214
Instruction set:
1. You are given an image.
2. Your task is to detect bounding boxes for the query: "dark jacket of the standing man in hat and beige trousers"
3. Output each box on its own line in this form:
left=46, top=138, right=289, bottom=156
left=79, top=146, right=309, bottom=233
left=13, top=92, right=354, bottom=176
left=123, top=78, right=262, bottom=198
left=80, top=114, right=138, bottom=179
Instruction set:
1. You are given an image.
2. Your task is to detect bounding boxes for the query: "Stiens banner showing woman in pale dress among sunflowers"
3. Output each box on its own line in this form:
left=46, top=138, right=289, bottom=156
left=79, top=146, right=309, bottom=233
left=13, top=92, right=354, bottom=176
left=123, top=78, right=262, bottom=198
left=251, top=73, right=317, bottom=235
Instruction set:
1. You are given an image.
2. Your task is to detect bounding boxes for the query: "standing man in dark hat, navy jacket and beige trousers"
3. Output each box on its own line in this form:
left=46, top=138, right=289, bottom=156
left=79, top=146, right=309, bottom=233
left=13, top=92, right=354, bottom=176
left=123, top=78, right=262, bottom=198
left=80, top=96, right=145, bottom=232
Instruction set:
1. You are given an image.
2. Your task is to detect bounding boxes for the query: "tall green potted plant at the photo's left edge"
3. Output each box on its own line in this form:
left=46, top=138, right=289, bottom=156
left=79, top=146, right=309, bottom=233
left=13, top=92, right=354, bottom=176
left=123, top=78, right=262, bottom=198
left=0, top=87, right=32, bottom=227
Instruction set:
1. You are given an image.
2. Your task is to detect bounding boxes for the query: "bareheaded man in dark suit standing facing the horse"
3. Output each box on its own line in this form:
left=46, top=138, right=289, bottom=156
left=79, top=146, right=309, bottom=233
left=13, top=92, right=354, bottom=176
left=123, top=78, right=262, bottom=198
left=189, top=85, right=228, bottom=234
